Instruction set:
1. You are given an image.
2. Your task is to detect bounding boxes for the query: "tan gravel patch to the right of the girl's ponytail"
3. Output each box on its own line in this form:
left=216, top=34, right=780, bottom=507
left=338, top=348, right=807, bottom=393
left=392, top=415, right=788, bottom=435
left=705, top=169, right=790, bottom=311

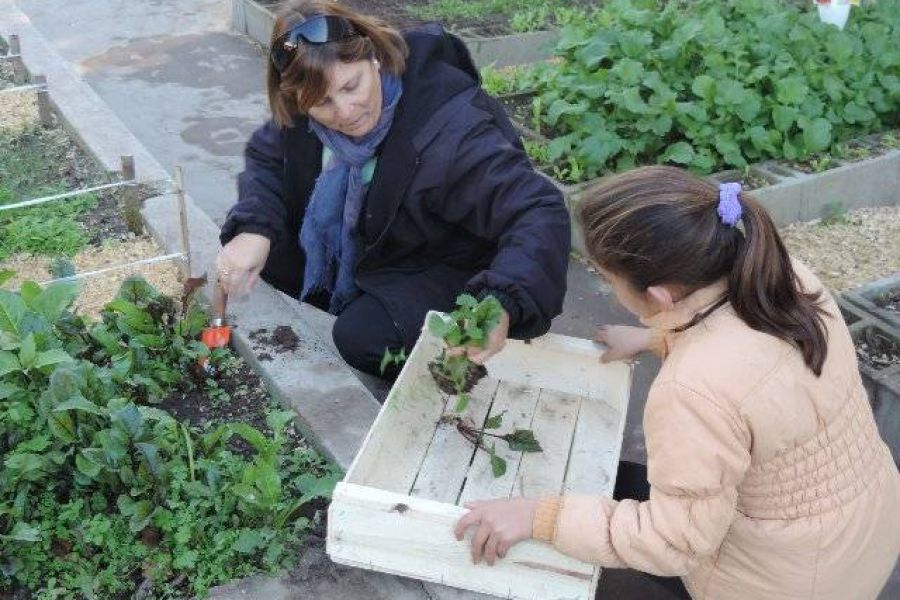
left=781, top=206, right=900, bottom=292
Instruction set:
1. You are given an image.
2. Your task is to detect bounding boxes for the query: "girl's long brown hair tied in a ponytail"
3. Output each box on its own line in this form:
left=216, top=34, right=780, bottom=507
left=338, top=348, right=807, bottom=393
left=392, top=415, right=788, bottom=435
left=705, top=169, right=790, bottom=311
left=578, top=166, right=827, bottom=376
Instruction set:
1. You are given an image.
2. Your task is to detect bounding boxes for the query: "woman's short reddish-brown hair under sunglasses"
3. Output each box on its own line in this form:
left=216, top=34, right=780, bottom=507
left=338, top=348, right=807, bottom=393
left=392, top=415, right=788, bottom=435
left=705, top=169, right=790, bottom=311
left=266, top=0, right=409, bottom=127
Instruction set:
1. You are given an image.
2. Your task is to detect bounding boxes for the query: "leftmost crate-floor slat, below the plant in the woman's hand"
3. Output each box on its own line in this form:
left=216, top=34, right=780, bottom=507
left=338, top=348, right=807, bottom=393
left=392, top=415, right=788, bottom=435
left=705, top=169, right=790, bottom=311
left=410, top=377, right=499, bottom=504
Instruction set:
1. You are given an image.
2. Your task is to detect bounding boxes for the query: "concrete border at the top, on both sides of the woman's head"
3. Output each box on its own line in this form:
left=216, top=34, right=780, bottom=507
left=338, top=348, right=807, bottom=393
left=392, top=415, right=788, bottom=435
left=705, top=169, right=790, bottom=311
left=231, top=0, right=560, bottom=67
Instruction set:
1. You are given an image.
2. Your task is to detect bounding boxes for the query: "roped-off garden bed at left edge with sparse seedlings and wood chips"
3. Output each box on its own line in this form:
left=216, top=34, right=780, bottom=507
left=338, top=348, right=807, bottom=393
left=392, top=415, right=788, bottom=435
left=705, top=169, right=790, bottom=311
left=0, top=120, right=178, bottom=302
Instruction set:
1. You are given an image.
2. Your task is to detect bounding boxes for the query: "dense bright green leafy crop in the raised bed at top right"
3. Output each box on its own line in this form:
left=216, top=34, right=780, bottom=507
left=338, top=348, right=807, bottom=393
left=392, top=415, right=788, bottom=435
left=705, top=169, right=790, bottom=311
left=506, top=0, right=900, bottom=180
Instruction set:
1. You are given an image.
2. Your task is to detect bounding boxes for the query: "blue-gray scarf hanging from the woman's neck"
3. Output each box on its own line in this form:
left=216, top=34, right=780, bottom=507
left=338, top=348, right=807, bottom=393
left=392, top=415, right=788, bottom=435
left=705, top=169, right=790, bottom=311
left=300, top=73, right=403, bottom=315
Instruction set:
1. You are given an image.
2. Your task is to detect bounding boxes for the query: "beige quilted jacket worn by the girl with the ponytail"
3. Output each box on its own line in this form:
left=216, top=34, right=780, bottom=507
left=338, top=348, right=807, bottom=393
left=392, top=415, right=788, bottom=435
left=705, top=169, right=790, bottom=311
left=534, top=265, right=900, bottom=600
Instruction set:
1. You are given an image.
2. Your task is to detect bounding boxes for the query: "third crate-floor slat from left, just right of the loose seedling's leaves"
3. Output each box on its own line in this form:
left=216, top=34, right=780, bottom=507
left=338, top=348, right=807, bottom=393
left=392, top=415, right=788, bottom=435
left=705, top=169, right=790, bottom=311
left=516, top=389, right=581, bottom=497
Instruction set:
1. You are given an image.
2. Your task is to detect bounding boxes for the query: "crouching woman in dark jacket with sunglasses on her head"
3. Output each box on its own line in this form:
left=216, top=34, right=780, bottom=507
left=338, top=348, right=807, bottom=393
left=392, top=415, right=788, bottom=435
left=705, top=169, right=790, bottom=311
left=217, top=0, right=569, bottom=374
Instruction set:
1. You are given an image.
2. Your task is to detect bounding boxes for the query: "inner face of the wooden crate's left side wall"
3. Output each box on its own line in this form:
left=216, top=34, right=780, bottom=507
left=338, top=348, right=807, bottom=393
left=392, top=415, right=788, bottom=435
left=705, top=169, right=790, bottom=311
left=344, top=335, right=445, bottom=494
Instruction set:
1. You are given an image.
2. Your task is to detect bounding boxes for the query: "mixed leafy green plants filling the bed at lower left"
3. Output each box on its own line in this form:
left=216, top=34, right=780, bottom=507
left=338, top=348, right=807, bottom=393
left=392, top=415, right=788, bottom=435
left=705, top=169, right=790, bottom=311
left=0, top=275, right=340, bottom=598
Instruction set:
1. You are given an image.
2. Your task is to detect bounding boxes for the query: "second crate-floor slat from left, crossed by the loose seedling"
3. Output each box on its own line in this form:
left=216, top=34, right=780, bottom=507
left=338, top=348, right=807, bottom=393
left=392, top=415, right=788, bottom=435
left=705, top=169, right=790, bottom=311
left=458, top=381, right=540, bottom=505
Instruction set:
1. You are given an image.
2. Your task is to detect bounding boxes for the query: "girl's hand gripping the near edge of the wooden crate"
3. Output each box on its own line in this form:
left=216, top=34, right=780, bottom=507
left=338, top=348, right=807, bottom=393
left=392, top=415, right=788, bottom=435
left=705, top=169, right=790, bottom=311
left=453, top=498, right=538, bottom=565
